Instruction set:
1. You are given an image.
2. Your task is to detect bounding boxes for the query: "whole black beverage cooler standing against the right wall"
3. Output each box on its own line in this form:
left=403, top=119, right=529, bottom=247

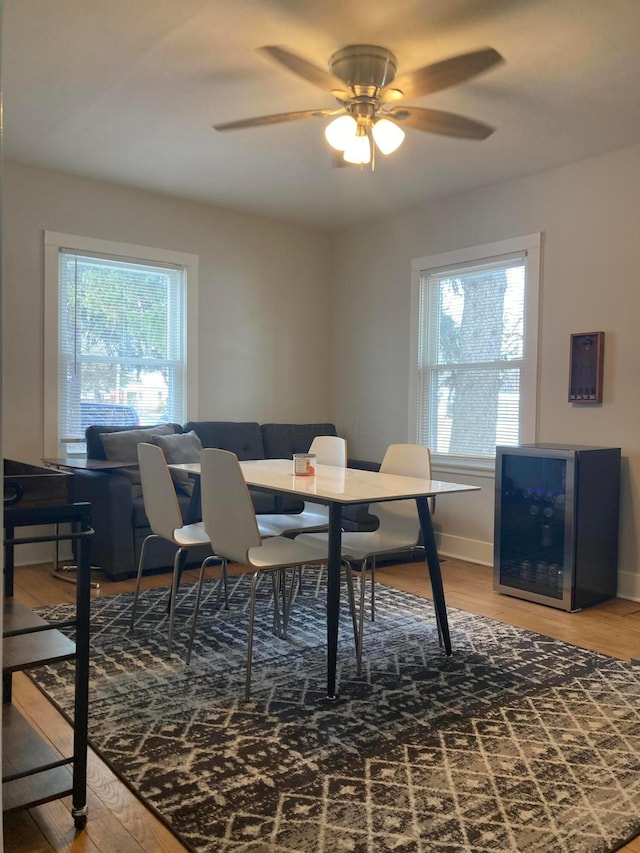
left=493, top=444, right=620, bottom=610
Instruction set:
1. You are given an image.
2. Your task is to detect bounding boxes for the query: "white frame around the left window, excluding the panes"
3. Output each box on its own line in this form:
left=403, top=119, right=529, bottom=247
left=43, top=231, right=199, bottom=457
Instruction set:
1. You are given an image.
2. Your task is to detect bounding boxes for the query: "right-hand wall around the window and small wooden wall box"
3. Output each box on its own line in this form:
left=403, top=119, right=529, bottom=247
left=332, top=147, right=640, bottom=600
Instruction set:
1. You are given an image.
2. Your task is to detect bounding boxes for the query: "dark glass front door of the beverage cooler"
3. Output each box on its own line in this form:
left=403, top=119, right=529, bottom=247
left=494, top=451, right=575, bottom=610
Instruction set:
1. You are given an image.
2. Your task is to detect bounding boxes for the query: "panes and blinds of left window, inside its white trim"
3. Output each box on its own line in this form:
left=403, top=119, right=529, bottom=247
left=58, top=249, right=185, bottom=450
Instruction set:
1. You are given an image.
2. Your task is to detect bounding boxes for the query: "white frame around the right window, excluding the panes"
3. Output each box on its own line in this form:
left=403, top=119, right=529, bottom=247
left=408, top=232, right=542, bottom=473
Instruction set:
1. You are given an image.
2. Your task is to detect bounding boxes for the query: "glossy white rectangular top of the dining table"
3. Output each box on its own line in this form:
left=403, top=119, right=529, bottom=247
left=169, top=459, right=480, bottom=504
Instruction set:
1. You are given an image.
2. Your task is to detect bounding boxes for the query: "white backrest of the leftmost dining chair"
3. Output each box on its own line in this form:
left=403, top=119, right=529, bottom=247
left=138, top=441, right=184, bottom=541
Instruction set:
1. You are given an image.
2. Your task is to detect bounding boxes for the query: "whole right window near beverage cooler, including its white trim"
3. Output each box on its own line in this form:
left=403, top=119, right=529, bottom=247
left=410, top=235, right=540, bottom=466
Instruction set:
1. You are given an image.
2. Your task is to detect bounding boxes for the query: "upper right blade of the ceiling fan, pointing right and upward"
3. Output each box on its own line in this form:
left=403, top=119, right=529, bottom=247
left=380, top=47, right=504, bottom=101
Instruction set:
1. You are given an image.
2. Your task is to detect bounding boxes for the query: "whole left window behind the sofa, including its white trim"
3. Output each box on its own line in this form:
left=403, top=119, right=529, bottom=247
left=45, top=233, right=197, bottom=455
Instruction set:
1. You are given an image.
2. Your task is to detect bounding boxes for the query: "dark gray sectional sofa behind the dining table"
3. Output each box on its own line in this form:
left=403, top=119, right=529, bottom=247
left=74, top=421, right=378, bottom=580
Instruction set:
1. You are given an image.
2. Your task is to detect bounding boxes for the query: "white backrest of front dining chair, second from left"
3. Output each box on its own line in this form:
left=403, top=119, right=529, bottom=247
left=200, top=447, right=262, bottom=565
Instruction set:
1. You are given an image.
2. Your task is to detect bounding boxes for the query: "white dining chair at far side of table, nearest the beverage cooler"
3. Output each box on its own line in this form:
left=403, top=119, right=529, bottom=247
left=296, top=444, right=431, bottom=672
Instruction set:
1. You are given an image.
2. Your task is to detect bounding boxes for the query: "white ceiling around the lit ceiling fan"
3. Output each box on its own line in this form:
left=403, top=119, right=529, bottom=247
left=2, top=0, right=640, bottom=227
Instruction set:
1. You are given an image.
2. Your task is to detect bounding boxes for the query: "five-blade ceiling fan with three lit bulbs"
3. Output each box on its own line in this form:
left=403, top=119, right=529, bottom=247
left=213, top=44, right=503, bottom=169
